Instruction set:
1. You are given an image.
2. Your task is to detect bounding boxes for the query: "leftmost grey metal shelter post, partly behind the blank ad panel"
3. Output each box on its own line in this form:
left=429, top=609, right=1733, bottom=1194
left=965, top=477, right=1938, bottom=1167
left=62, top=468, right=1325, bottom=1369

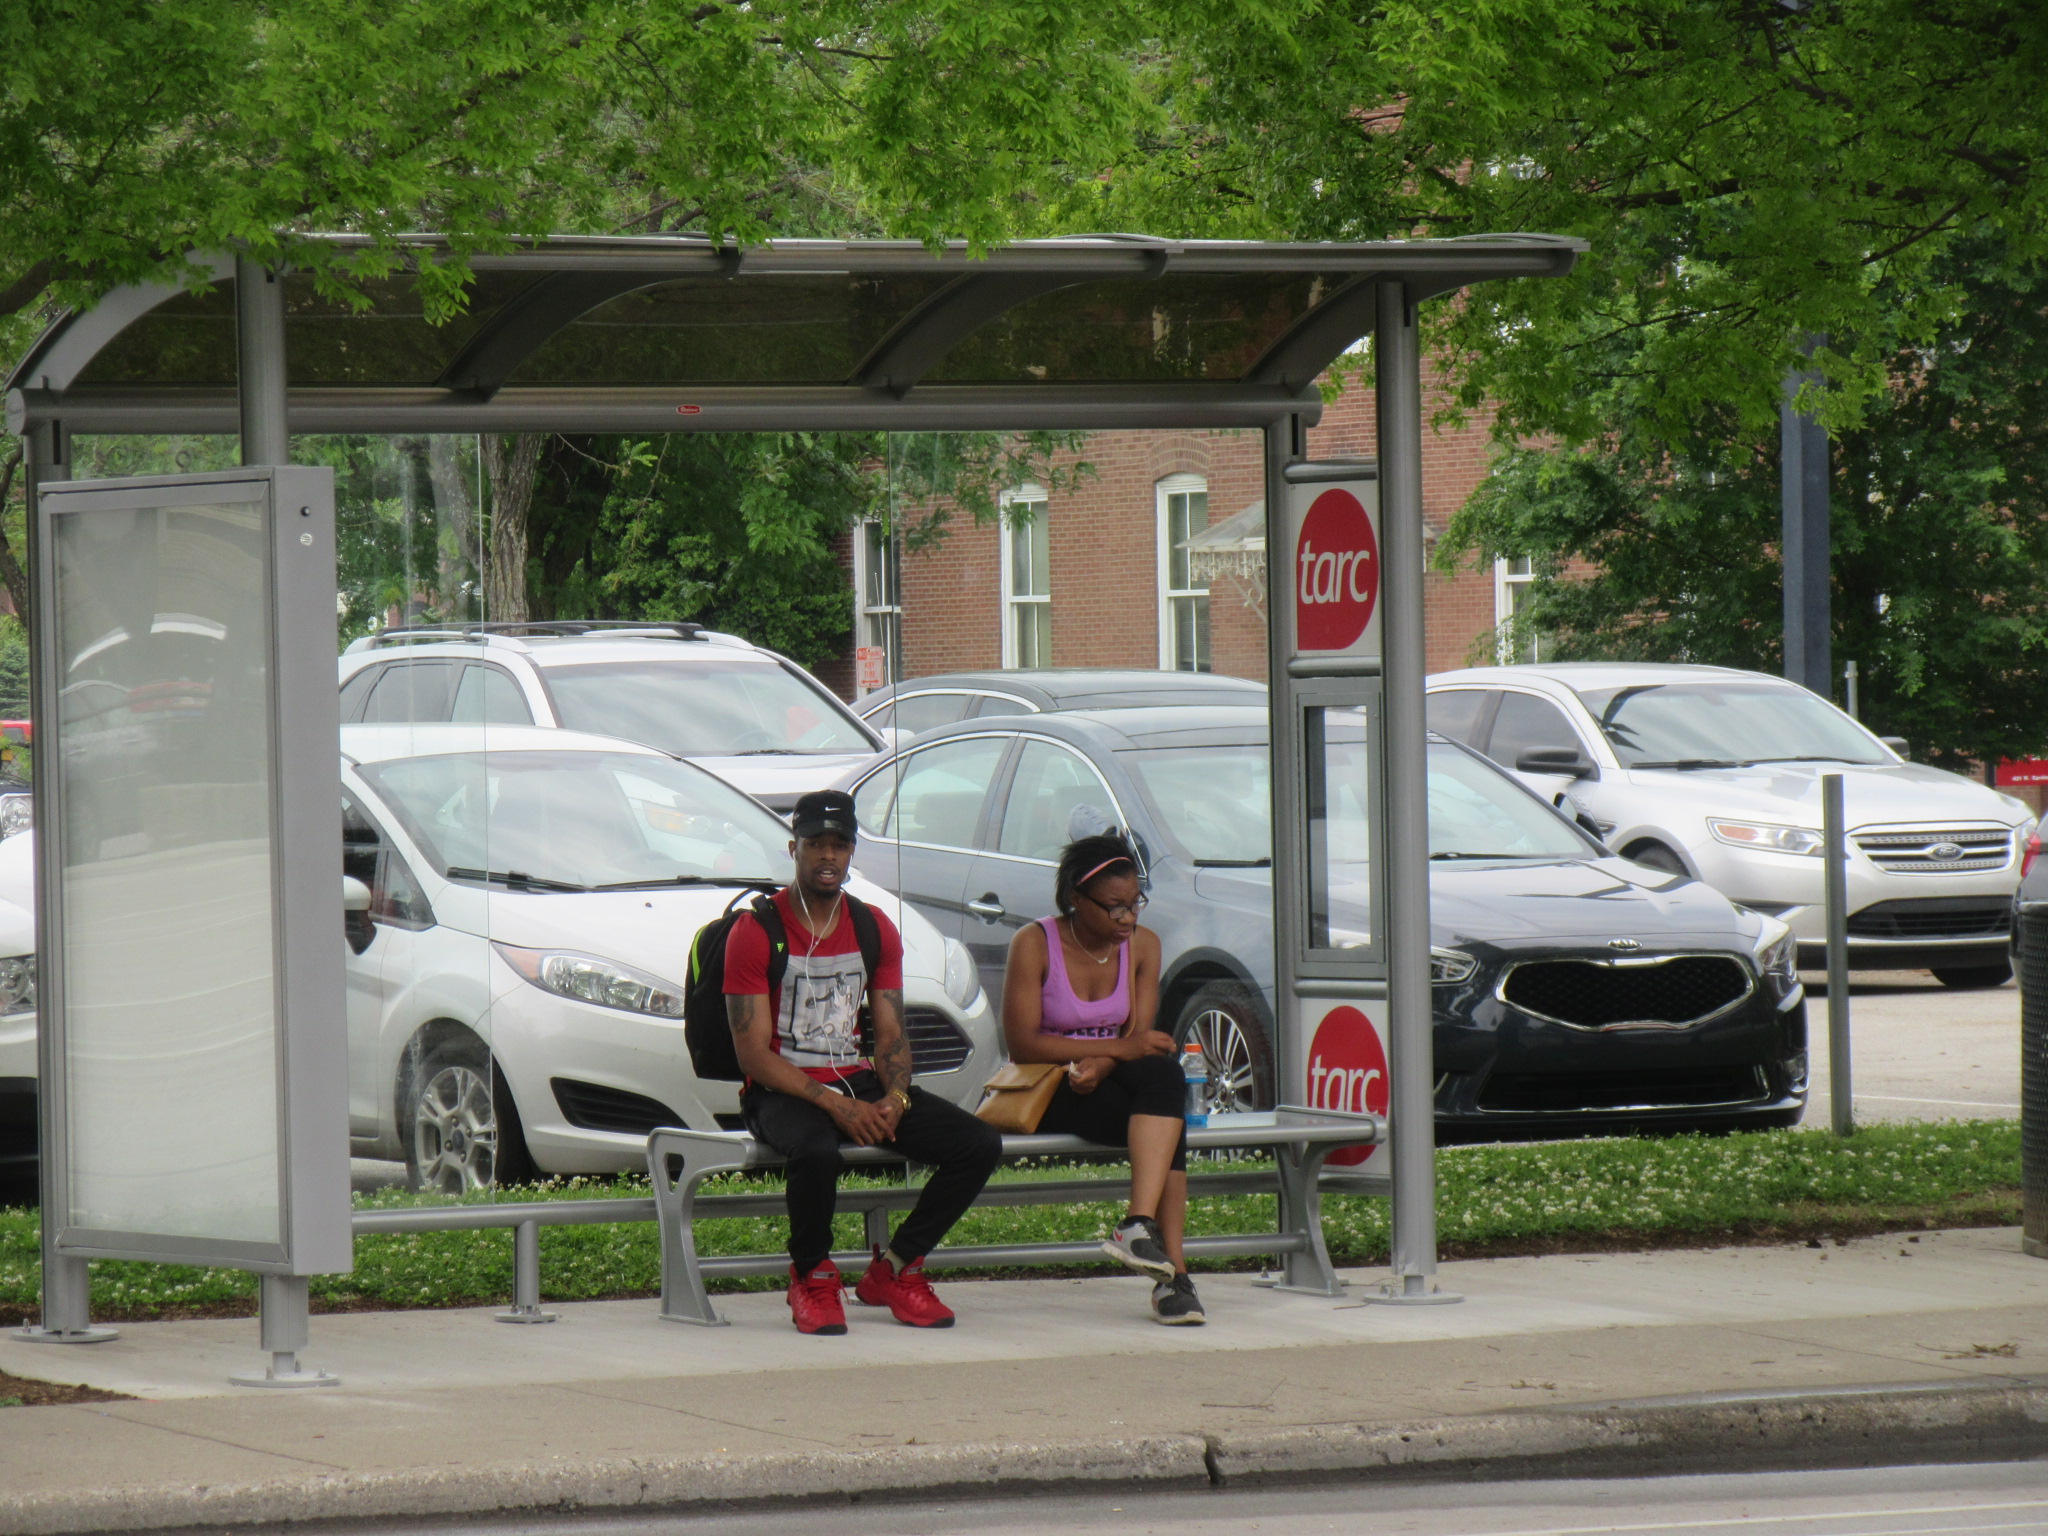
left=14, top=422, right=119, bottom=1343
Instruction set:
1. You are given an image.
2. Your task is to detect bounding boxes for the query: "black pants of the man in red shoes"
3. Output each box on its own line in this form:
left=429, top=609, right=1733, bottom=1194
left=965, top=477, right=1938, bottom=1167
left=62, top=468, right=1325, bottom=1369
left=739, top=1071, right=1004, bottom=1274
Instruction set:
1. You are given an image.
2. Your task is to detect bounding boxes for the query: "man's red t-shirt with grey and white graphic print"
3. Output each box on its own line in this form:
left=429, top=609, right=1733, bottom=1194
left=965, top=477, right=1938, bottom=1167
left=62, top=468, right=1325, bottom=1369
left=725, top=887, right=903, bottom=1083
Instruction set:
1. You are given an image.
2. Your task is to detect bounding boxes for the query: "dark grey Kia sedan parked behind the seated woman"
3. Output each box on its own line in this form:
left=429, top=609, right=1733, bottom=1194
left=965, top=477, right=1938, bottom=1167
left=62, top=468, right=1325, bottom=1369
left=846, top=705, right=1806, bottom=1141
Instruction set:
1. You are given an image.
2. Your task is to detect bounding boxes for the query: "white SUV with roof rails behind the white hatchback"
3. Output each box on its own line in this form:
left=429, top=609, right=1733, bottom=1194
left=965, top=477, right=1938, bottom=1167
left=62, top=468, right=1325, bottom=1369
left=340, top=621, right=887, bottom=815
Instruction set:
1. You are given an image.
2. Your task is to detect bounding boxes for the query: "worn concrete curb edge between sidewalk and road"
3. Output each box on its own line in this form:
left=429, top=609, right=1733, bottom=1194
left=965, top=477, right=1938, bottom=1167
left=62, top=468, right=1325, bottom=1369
left=0, top=1378, right=2048, bottom=1536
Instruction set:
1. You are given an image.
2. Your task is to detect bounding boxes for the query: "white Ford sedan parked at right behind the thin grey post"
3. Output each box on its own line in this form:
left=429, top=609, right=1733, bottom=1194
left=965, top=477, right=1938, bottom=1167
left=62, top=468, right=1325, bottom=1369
left=1430, top=662, right=2034, bottom=987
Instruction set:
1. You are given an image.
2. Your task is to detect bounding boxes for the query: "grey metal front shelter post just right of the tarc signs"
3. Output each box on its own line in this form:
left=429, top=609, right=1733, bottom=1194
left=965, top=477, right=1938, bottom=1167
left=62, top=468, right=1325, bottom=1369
left=1372, top=283, right=1458, bottom=1303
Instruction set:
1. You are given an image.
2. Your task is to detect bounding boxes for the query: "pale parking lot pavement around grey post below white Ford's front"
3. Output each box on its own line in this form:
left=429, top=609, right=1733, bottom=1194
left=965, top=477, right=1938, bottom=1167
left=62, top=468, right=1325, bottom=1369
left=1802, top=971, right=2019, bottom=1124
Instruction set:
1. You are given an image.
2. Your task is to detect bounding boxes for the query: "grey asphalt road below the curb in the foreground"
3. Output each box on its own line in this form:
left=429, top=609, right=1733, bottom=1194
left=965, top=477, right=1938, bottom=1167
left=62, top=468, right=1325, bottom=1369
left=299, top=1466, right=2048, bottom=1536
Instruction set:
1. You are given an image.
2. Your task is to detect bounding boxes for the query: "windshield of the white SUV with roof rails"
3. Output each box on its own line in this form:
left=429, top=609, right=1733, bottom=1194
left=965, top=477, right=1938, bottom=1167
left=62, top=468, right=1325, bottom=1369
left=541, top=659, right=874, bottom=758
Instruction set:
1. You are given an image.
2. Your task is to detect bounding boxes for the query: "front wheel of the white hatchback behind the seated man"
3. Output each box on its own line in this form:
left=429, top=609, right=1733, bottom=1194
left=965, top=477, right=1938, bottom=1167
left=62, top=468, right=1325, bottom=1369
left=399, top=1034, right=539, bottom=1196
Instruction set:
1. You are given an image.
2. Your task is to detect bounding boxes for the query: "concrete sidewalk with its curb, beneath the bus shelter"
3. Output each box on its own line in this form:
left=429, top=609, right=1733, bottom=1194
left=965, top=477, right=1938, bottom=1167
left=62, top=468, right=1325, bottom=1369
left=0, top=1229, right=2048, bottom=1532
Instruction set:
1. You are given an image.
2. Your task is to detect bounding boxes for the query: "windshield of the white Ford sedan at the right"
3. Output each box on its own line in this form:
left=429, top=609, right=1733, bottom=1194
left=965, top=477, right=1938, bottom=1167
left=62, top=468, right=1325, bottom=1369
left=1579, top=682, right=1890, bottom=768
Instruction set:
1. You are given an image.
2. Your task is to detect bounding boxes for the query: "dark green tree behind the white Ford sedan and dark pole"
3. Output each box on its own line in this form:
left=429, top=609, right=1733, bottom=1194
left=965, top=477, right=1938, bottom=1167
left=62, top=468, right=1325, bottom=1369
left=1438, top=250, right=2048, bottom=766
